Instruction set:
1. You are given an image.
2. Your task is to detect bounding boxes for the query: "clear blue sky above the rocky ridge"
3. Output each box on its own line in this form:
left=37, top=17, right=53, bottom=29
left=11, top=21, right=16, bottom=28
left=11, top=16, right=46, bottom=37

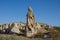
left=0, top=0, right=60, bottom=26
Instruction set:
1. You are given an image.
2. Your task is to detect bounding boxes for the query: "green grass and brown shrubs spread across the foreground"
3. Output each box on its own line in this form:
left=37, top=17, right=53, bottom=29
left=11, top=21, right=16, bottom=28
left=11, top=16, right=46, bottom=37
left=0, top=27, right=60, bottom=40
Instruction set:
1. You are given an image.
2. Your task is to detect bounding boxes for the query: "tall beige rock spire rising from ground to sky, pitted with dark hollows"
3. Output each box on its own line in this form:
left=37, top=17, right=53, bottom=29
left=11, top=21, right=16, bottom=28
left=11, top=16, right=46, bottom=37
left=26, top=7, right=36, bottom=37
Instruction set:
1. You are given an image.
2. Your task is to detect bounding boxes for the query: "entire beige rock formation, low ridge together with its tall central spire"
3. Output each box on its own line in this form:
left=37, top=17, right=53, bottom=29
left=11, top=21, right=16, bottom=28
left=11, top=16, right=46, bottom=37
left=0, top=7, right=51, bottom=37
